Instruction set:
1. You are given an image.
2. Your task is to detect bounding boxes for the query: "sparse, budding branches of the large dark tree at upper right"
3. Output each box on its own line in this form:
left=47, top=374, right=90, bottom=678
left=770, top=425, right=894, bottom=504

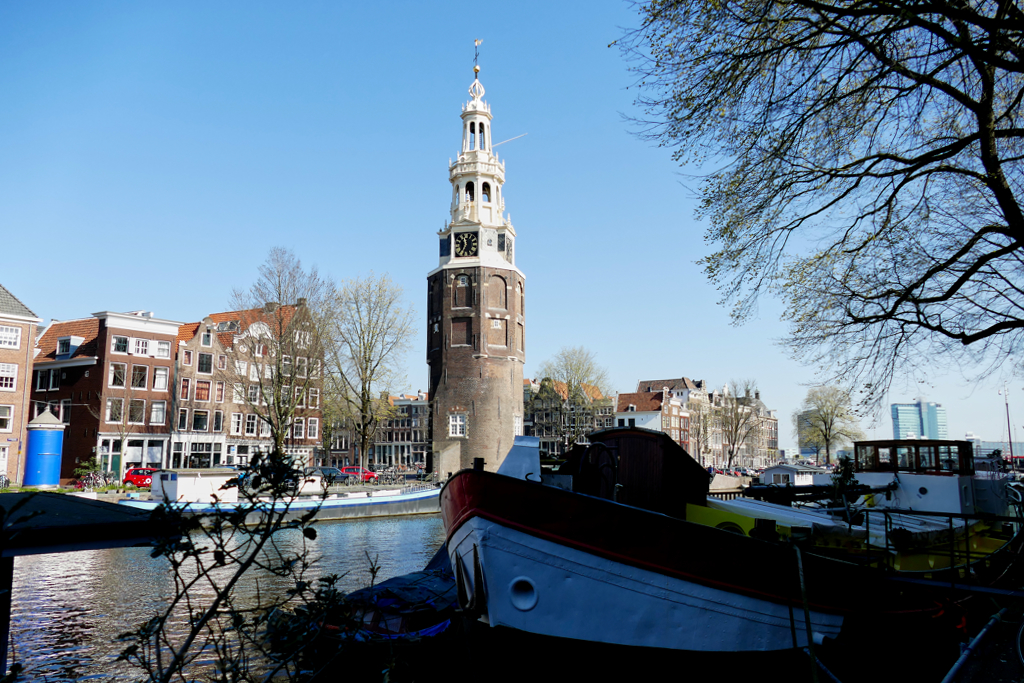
left=617, top=0, right=1024, bottom=400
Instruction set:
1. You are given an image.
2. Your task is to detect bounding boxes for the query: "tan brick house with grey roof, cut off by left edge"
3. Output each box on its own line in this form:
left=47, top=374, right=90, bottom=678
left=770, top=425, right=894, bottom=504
left=0, top=285, right=42, bottom=481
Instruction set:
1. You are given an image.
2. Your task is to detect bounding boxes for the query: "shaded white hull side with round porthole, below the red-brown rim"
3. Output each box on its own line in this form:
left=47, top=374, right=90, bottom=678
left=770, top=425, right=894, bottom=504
left=447, top=517, right=843, bottom=652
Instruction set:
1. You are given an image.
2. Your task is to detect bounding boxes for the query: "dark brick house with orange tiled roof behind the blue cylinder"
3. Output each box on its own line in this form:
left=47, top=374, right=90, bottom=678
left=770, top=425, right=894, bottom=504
left=32, top=310, right=181, bottom=483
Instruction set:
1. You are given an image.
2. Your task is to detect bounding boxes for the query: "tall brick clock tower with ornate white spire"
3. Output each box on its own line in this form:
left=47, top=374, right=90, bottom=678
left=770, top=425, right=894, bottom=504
left=427, top=67, right=525, bottom=477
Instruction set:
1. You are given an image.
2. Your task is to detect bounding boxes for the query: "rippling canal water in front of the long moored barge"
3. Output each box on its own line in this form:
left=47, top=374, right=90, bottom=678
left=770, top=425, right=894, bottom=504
left=9, top=514, right=444, bottom=681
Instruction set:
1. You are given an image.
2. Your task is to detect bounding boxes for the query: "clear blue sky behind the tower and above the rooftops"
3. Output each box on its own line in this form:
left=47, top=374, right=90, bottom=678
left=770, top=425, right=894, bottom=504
left=0, top=0, right=1024, bottom=450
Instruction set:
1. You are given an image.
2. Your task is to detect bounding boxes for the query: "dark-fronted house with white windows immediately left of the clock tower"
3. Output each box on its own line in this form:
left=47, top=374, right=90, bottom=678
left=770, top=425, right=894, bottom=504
left=371, top=391, right=431, bottom=467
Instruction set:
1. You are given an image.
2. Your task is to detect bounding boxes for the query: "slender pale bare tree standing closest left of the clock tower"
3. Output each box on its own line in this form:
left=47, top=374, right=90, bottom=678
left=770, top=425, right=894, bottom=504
left=324, top=273, right=413, bottom=466
